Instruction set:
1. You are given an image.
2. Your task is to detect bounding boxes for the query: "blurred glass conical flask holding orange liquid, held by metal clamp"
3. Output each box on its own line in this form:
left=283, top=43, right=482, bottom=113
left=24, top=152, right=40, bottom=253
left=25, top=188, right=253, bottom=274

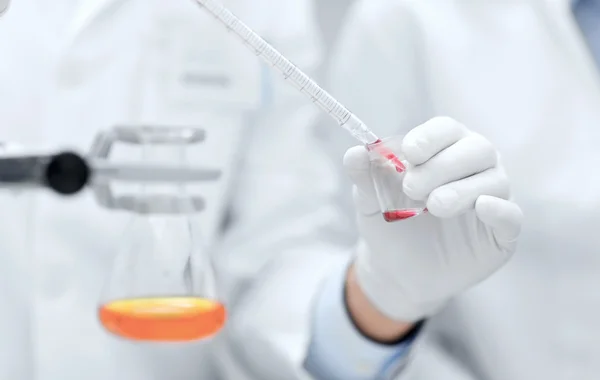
left=98, top=129, right=226, bottom=342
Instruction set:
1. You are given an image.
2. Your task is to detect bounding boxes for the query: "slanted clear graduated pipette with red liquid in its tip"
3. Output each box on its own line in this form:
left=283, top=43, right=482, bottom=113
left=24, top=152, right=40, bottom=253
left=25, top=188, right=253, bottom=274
left=194, top=0, right=405, bottom=172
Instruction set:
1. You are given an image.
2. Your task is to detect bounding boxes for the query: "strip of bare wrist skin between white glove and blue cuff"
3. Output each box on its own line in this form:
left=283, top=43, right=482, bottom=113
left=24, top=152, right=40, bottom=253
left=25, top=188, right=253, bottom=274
left=344, top=264, right=422, bottom=344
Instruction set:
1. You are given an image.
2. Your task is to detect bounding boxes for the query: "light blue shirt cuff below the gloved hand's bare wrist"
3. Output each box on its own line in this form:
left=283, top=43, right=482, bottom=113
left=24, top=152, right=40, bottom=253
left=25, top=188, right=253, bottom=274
left=304, top=267, right=414, bottom=380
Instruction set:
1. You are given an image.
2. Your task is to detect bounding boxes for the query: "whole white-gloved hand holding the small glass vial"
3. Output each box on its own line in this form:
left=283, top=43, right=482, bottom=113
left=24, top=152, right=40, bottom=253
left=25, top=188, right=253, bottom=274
left=344, top=117, right=523, bottom=322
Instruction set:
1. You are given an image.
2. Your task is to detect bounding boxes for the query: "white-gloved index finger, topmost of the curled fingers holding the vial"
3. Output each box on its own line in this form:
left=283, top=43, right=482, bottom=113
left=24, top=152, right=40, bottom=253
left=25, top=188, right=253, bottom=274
left=402, top=117, right=469, bottom=165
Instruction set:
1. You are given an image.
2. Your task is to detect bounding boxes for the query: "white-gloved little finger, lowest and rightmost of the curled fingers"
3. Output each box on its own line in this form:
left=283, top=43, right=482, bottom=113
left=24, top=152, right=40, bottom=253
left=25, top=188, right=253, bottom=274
left=475, top=195, right=523, bottom=249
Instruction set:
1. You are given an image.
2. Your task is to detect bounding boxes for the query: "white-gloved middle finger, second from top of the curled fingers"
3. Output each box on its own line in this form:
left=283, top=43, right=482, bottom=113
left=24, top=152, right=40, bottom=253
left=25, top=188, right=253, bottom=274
left=403, top=134, right=498, bottom=202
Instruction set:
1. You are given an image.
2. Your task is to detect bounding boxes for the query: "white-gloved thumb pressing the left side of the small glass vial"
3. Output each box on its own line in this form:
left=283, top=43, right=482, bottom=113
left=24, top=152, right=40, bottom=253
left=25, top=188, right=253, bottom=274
left=344, top=146, right=380, bottom=215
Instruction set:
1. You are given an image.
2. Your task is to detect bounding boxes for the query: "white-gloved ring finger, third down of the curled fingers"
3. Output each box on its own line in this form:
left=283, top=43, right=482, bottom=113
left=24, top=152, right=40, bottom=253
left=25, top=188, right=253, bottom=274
left=427, top=168, right=510, bottom=218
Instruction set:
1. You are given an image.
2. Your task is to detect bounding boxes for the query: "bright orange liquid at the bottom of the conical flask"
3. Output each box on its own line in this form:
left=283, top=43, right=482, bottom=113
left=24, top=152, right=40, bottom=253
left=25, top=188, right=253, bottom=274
left=99, top=297, right=227, bottom=342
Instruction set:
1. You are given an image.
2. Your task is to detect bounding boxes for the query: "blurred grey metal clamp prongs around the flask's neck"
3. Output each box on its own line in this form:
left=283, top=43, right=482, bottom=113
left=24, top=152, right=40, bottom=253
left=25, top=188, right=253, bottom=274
left=88, top=126, right=221, bottom=214
